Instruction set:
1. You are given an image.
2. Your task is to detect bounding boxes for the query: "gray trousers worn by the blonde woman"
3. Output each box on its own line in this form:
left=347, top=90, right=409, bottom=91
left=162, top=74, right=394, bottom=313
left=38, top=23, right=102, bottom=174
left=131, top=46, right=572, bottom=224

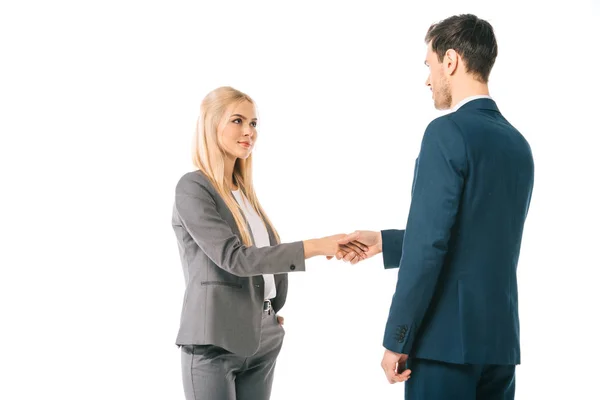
left=181, top=311, right=285, bottom=400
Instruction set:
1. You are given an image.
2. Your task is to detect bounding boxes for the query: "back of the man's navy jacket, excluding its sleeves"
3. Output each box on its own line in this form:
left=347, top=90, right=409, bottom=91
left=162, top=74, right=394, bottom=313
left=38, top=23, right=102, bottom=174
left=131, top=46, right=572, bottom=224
left=412, top=99, right=534, bottom=364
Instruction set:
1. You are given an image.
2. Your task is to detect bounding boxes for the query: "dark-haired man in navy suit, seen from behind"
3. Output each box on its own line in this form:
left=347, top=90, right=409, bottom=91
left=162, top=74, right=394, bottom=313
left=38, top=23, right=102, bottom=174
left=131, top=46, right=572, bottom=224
left=337, top=15, right=534, bottom=400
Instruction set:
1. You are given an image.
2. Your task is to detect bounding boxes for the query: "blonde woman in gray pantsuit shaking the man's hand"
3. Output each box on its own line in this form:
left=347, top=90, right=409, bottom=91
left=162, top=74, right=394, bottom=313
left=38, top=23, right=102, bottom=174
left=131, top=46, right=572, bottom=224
left=173, top=87, right=366, bottom=400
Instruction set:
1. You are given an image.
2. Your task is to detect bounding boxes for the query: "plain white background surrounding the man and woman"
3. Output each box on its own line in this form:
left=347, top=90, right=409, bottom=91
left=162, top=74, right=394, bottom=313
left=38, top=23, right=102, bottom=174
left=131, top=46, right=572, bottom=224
left=0, top=0, right=600, bottom=400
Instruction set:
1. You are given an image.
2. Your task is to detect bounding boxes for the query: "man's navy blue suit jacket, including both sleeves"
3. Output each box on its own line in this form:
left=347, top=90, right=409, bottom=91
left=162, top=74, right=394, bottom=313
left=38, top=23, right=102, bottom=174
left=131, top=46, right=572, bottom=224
left=382, top=98, right=534, bottom=364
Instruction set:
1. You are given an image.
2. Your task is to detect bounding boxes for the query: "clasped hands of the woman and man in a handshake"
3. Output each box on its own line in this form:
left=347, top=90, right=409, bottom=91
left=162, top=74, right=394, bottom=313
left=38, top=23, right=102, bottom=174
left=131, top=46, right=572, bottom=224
left=304, top=231, right=382, bottom=264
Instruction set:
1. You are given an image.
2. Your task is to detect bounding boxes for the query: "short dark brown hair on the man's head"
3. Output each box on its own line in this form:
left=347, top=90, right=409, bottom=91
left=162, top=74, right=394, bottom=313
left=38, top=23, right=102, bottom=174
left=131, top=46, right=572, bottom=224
left=425, top=14, right=498, bottom=83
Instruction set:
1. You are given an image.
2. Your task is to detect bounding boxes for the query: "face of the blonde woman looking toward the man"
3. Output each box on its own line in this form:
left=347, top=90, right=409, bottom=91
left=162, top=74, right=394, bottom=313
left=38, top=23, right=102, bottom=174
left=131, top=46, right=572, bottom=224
left=219, top=101, right=257, bottom=160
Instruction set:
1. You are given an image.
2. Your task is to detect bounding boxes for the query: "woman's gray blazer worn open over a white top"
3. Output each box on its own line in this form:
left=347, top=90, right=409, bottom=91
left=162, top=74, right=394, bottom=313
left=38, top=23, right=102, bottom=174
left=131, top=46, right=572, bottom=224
left=172, top=171, right=305, bottom=357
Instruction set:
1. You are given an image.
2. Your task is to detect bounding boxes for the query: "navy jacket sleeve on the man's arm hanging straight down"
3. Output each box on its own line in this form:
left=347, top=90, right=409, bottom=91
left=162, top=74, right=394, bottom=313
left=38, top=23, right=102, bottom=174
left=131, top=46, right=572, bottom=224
left=383, top=116, right=468, bottom=354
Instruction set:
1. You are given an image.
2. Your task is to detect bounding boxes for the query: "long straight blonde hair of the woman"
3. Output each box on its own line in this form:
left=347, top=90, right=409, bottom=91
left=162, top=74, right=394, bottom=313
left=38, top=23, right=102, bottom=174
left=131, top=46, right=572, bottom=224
left=192, top=86, right=280, bottom=246
